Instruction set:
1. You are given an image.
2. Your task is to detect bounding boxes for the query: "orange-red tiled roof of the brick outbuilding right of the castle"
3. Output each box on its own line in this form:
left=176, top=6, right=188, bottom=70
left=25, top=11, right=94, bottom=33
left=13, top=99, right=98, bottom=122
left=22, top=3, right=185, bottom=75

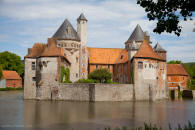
left=167, top=64, right=189, bottom=76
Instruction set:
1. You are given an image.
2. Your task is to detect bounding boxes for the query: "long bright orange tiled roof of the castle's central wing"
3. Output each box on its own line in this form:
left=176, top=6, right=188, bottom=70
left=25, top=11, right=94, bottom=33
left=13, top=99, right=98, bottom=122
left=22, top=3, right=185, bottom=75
left=87, top=47, right=123, bottom=64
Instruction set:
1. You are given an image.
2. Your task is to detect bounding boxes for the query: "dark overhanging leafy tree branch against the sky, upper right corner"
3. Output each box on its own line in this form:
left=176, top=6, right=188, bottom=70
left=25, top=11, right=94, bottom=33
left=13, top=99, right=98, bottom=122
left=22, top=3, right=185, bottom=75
left=137, top=0, right=195, bottom=36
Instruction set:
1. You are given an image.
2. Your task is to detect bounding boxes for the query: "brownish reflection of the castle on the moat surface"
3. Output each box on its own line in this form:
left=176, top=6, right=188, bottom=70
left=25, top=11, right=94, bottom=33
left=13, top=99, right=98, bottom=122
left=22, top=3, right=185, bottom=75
left=24, top=100, right=186, bottom=129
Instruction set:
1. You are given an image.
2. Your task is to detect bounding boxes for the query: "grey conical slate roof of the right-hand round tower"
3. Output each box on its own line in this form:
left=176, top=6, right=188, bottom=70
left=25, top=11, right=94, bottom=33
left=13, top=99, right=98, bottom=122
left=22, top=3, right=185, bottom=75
left=126, top=24, right=144, bottom=43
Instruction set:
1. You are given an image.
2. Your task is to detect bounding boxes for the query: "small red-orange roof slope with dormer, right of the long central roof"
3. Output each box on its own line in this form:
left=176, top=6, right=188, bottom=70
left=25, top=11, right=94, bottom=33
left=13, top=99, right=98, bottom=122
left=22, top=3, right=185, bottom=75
left=115, top=49, right=128, bottom=64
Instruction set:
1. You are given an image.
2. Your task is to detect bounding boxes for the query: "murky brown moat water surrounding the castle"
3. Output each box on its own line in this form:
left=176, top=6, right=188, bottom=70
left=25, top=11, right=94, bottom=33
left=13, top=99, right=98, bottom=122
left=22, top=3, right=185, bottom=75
left=0, top=91, right=195, bottom=130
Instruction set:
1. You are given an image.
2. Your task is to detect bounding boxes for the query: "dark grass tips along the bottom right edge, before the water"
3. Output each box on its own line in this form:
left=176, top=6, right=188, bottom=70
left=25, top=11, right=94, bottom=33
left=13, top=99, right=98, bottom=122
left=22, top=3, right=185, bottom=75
left=105, top=121, right=195, bottom=130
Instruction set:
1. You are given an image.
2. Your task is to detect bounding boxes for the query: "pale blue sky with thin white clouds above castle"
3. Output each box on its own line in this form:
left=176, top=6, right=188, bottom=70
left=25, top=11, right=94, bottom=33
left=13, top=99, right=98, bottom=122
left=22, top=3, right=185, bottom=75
left=0, top=0, right=195, bottom=62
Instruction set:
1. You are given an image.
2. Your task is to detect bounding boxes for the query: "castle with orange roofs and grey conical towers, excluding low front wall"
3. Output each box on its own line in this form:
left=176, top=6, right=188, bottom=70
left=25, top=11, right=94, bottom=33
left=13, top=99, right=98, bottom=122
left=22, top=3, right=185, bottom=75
left=24, top=13, right=167, bottom=100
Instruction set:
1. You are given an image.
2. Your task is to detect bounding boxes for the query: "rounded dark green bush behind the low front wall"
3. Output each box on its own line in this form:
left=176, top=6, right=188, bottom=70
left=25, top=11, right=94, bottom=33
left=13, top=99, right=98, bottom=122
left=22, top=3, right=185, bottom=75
left=88, top=68, right=112, bottom=83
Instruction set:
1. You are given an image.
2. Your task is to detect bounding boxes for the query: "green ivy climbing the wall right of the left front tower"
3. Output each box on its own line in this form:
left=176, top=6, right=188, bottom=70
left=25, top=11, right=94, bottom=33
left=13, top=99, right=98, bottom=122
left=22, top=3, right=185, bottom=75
left=60, top=66, right=71, bottom=83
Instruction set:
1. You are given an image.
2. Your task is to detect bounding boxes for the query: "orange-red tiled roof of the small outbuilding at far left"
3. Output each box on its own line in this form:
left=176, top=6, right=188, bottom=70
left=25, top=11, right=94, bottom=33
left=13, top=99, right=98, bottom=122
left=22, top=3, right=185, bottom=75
left=2, top=70, right=22, bottom=79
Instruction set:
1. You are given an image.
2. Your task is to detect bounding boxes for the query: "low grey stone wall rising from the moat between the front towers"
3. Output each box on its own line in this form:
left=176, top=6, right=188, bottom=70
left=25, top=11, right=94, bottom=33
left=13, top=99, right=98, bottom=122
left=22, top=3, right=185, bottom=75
left=37, top=84, right=133, bottom=101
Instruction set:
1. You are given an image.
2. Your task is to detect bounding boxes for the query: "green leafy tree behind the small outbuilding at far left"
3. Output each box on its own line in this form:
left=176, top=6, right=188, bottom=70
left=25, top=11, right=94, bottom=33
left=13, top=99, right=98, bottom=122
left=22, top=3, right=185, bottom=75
left=0, top=51, right=24, bottom=75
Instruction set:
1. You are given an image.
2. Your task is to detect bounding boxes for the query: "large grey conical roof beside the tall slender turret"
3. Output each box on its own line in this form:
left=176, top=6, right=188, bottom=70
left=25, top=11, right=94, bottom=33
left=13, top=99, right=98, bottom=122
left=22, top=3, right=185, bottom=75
left=53, top=19, right=80, bottom=41
